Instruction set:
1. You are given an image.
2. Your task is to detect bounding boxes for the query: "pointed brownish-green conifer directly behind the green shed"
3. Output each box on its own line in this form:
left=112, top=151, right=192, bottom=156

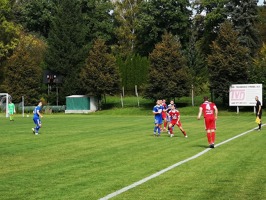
left=80, top=39, right=120, bottom=106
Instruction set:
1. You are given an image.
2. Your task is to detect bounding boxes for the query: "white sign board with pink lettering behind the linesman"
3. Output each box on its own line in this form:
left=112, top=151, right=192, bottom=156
left=229, top=84, right=262, bottom=106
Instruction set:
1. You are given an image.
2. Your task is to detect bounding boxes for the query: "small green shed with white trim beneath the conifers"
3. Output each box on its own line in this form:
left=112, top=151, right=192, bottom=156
left=65, top=95, right=97, bottom=113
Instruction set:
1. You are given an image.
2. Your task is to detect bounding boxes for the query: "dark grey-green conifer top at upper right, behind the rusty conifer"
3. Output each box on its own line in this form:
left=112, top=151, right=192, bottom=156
left=227, top=0, right=261, bottom=57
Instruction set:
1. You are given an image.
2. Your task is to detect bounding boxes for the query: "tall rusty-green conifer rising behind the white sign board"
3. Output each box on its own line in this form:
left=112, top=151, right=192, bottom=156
left=208, top=22, right=252, bottom=104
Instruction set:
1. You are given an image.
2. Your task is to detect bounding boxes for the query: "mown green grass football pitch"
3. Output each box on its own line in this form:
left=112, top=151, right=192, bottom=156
left=0, top=113, right=266, bottom=200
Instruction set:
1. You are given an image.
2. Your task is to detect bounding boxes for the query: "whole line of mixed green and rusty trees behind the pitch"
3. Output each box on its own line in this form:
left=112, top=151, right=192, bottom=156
left=0, top=0, right=266, bottom=105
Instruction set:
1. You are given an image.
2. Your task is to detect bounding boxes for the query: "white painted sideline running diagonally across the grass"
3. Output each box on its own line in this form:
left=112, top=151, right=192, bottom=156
left=99, top=124, right=264, bottom=200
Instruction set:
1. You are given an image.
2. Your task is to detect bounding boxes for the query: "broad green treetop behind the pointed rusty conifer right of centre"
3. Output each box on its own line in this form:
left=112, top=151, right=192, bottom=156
left=136, top=0, right=192, bottom=56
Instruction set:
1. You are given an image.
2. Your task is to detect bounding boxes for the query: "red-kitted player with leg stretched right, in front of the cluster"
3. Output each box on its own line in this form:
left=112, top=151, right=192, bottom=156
left=168, top=105, right=187, bottom=137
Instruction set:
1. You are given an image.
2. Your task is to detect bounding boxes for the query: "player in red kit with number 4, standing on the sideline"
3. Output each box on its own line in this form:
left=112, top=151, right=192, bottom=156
left=198, top=97, right=218, bottom=148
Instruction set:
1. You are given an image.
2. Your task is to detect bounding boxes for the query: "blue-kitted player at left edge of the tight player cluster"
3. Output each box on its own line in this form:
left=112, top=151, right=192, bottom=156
left=152, top=100, right=163, bottom=136
